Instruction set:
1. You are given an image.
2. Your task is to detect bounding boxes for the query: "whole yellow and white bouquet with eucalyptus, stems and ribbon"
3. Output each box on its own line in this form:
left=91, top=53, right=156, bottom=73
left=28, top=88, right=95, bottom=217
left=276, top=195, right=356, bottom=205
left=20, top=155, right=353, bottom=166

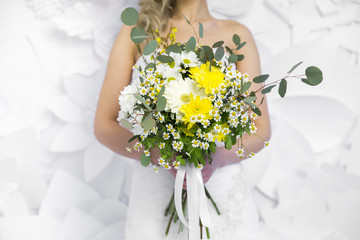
left=118, top=8, right=322, bottom=238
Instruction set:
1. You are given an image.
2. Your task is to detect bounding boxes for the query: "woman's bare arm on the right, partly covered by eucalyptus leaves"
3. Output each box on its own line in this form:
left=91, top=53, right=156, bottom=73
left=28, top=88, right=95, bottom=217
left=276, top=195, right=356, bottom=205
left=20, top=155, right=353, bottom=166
left=207, top=22, right=271, bottom=169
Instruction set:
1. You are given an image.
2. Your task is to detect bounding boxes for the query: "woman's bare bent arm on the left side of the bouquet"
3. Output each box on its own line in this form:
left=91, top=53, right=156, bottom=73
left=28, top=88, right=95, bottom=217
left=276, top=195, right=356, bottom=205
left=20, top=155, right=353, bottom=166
left=94, top=25, right=147, bottom=160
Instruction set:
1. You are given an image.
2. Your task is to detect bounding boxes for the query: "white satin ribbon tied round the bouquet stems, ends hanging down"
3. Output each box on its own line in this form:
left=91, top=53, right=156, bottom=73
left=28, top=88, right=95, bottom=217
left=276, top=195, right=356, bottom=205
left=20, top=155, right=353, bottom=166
left=175, top=164, right=212, bottom=240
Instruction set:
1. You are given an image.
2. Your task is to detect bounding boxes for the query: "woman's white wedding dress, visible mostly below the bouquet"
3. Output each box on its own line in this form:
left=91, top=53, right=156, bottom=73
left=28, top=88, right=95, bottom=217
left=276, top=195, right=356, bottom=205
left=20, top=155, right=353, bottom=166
left=125, top=58, right=271, bottom=240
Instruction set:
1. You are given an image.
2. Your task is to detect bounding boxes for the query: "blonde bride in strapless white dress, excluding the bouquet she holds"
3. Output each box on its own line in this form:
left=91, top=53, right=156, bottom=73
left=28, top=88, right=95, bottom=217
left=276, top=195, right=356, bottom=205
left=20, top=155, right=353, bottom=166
left=94, top=0, right=271, bottom=240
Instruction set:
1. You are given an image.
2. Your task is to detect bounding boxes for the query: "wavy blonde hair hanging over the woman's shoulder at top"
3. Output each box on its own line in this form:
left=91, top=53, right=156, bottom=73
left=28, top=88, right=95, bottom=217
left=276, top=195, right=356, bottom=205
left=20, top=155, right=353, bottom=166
left=138, top=0, right=176, bottom=33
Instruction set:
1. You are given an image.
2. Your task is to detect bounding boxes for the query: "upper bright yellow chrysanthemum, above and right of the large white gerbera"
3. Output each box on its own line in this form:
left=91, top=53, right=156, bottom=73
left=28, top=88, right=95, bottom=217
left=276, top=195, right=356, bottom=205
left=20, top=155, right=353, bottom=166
left=190, top=62, right=225, bottom=94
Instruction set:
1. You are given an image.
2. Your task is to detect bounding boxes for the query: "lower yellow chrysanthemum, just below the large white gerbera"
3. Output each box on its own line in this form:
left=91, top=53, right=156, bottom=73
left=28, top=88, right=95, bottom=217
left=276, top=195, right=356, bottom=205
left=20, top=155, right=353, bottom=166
left=179, top=93, right=213, bottom=128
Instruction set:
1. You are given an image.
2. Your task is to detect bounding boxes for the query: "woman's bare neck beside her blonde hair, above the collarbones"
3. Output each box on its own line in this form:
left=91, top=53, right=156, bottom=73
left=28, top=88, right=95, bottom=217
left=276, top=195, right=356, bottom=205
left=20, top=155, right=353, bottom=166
left=173, top=0, right=211, bottom=22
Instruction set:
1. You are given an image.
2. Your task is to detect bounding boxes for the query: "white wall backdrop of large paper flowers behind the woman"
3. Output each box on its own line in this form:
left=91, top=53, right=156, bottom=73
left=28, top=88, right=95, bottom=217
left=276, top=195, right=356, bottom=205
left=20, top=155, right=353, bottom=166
left=0, top=0, right=360, bottom=240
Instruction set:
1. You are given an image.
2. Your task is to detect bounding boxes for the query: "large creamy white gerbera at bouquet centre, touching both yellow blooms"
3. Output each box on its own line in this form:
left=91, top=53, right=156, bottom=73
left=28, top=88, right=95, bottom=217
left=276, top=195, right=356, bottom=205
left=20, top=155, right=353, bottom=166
left=164, top=78, right=206, bottom=116
